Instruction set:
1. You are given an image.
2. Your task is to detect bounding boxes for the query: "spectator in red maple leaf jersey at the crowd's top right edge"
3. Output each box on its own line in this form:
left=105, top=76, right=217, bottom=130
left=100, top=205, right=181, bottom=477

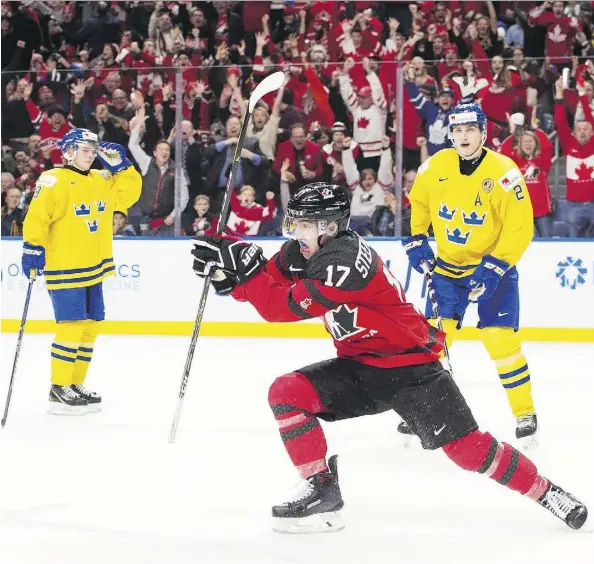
left=528, top=2, right=581, bottom=70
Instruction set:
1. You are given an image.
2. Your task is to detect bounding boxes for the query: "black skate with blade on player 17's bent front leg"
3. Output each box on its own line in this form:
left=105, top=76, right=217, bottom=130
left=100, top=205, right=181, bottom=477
left=272, top=455, right=344, bottom=533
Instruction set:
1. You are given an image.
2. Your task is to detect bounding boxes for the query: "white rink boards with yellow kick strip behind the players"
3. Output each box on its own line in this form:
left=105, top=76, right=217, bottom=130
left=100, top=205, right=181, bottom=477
left=1, top=238, right=594, bottom=342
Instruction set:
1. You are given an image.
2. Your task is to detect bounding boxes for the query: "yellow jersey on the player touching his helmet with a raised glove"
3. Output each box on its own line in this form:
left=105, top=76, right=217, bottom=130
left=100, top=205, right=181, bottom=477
left=23, top=167, right=142, bottom=290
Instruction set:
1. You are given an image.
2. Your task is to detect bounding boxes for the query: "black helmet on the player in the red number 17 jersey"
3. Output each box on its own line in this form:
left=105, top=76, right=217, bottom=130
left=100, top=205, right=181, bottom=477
left=283, top=182, right=351, bottom=237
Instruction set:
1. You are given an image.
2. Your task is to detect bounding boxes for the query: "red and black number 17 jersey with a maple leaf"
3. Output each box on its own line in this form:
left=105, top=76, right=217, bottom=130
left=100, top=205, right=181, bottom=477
left=232, top=231, right=444, bottom=368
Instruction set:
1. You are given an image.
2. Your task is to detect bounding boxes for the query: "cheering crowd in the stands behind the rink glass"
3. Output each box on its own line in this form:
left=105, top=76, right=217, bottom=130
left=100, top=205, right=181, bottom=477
left=1, top=0, right=594, bottom=237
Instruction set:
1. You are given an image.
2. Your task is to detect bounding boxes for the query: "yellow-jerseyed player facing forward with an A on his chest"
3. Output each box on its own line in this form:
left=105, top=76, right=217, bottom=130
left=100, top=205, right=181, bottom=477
left=403, top=104, right=537, bottom=445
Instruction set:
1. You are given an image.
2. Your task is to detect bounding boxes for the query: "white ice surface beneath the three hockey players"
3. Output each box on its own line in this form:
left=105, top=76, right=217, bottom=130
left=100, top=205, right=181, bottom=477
left=0, top=334, right=594, bottom=564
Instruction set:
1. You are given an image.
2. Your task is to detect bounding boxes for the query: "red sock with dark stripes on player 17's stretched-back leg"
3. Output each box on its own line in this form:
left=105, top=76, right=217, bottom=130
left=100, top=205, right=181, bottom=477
left=443, top=431, right=548, bottom=499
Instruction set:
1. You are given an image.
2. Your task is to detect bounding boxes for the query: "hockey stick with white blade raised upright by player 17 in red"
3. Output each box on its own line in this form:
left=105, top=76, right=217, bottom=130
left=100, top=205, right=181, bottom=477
left=169, top=71, right=285, bottom=443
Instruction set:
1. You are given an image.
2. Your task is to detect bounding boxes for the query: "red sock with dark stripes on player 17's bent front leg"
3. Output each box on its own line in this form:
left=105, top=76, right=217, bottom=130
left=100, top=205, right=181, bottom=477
left=268, top=372, right=328, bottom=479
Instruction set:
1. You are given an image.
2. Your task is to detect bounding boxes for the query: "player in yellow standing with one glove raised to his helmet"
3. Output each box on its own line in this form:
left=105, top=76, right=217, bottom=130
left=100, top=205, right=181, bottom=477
left=22, top=129, right=142, bottom=415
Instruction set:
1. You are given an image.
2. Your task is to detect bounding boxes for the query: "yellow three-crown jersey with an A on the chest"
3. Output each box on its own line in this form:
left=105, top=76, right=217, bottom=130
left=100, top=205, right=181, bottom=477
left=409, top=149, right=534, bottom=278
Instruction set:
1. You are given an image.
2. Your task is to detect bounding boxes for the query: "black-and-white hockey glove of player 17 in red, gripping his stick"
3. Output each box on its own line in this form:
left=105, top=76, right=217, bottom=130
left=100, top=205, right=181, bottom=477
left=192, top=235, right=266, bottom=284
